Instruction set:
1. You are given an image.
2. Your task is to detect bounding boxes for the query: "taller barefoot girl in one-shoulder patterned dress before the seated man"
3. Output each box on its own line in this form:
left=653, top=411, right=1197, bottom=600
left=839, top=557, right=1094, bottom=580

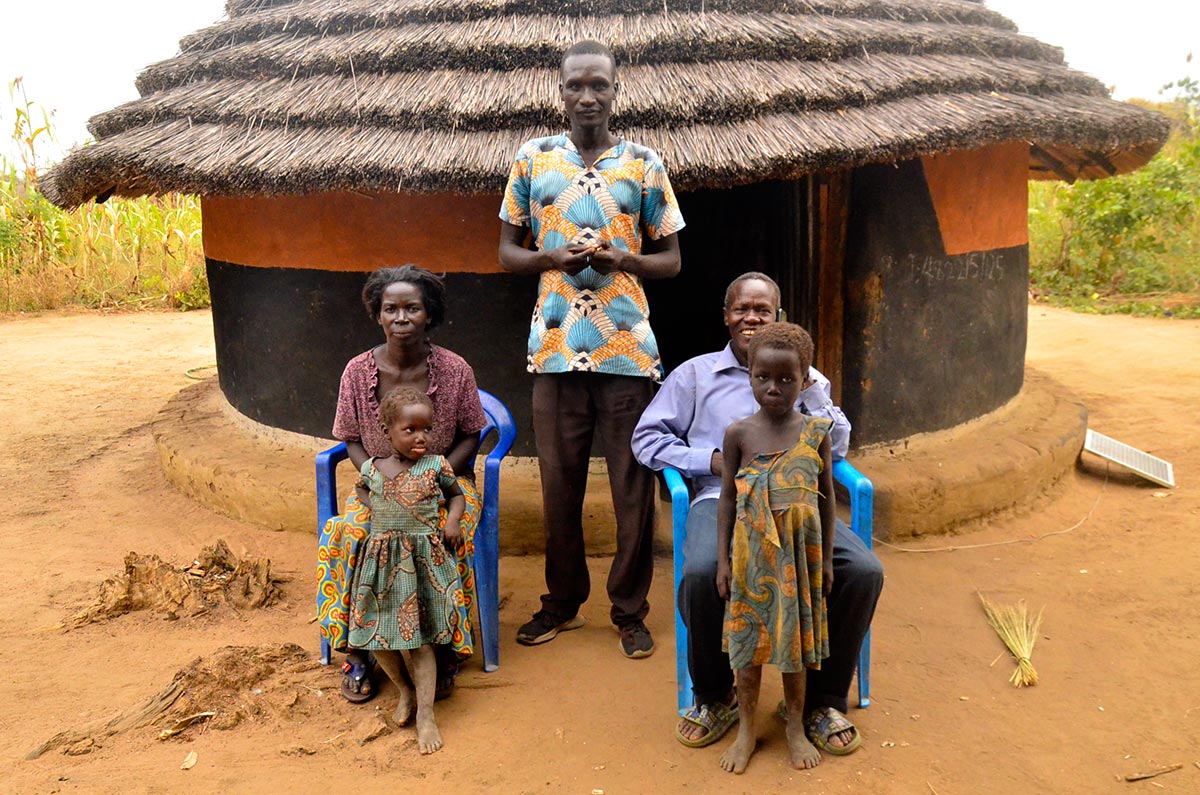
left=716, top=323, right=834, bottom=773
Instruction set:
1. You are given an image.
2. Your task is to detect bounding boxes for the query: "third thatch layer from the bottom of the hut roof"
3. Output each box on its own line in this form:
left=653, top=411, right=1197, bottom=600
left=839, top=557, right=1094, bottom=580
left=138, top=12, right=1062, bottom=95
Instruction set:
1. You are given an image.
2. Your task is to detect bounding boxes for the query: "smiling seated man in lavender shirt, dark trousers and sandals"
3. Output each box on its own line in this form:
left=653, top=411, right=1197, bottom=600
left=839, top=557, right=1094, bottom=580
left=632, top=273, right=883, bottom=755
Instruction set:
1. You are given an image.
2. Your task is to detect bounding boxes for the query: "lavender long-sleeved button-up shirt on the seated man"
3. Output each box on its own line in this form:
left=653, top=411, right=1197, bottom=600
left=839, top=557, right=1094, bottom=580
left=632, top=345, right=850, bottom=502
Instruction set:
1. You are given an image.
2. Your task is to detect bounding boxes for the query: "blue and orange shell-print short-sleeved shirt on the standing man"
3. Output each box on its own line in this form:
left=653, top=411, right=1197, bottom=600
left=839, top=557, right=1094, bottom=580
left=500, top=133, right=684, bottom=381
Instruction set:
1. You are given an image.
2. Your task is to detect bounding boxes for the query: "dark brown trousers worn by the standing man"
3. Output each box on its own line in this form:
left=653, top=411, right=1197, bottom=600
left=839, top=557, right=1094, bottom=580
left=533, top=372, right=654, bottom=626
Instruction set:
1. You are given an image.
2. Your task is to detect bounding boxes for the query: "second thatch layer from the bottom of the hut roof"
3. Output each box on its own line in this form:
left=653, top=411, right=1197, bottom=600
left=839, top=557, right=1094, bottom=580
left=89, top=54, right=1106, bottom=138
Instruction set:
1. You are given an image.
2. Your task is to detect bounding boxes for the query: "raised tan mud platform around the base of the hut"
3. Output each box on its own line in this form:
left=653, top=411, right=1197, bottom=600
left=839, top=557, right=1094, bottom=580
left=154, top=371, right=1087, bottom=555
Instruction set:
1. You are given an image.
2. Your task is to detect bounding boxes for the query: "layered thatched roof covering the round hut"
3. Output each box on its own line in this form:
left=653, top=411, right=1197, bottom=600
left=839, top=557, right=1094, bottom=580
left=43, top=0, right=1168, bottom=205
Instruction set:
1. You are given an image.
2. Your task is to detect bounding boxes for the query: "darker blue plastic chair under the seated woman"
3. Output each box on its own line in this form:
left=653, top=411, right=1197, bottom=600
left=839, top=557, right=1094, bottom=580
left=317, top=389, right=517, bottom=671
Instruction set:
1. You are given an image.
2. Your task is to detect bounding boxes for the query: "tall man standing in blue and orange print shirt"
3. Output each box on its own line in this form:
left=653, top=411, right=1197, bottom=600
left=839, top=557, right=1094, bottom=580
left=499, top=41, right=684, bottom=658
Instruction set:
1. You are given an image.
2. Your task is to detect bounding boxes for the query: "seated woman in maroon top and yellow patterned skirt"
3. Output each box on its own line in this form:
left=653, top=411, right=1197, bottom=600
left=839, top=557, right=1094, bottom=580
left=317, top=265, right=487, bottom=703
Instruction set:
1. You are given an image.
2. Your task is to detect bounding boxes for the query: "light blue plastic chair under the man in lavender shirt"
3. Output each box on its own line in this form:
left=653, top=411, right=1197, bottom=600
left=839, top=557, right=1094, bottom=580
left=662, top=459, right=875, bottom=715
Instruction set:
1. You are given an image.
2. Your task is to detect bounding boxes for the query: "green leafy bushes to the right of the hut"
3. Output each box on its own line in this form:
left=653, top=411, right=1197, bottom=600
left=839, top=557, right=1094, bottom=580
left=1030, top=79, right=1200, bottom=317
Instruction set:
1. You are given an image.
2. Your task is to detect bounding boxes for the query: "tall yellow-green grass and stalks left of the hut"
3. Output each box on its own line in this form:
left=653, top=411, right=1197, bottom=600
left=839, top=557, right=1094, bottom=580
left=0, top=78, right=210, bottom=312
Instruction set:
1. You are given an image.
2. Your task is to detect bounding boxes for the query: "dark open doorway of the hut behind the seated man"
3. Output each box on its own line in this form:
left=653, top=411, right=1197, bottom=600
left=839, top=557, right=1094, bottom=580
left=647, top=172, right=850, bottom=401
